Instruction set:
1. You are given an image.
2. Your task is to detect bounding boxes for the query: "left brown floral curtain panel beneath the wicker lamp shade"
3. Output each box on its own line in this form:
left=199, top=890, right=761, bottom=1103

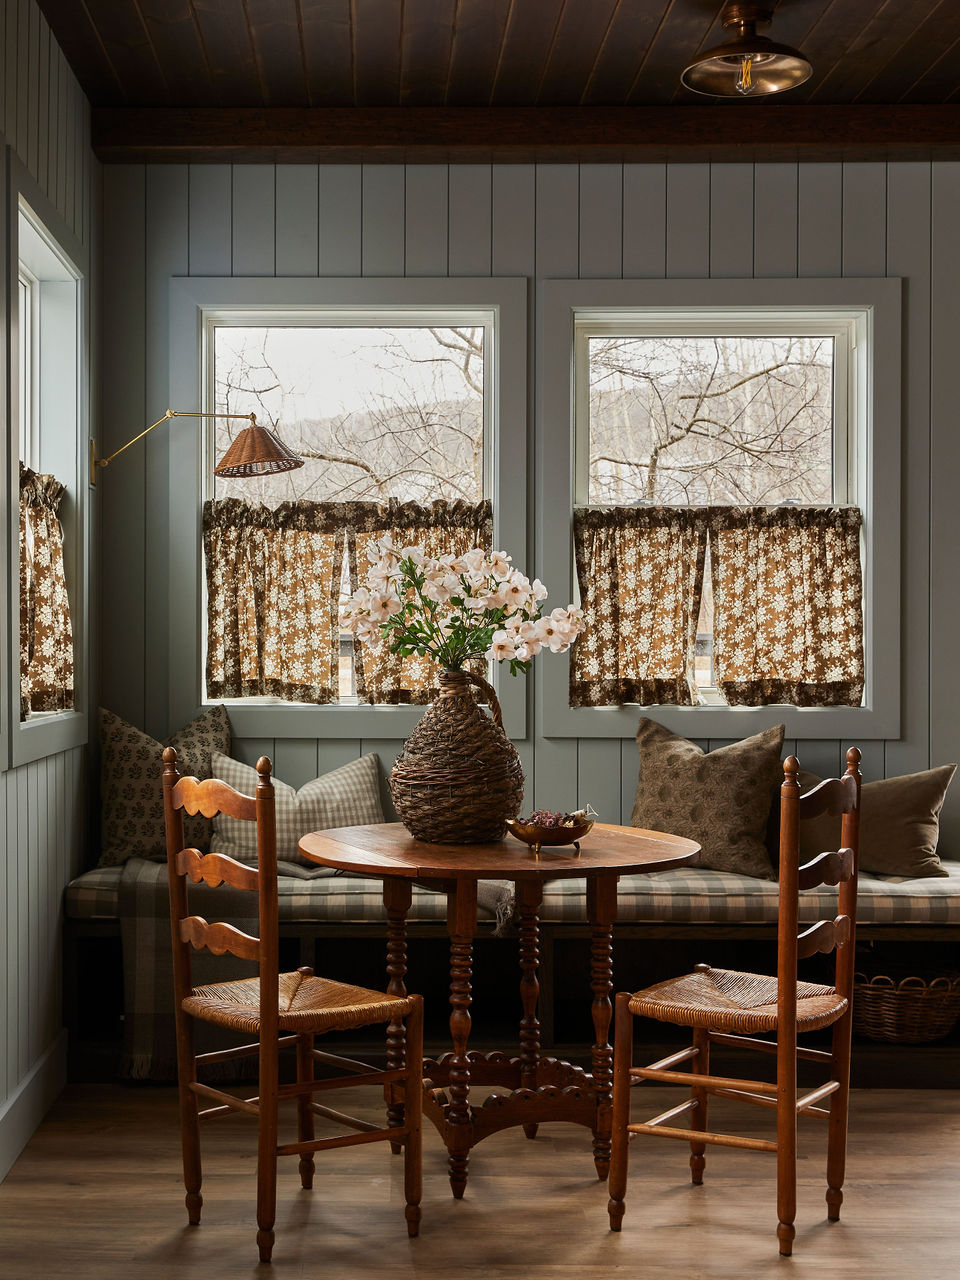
left=204, top=498, right=346, bottom=703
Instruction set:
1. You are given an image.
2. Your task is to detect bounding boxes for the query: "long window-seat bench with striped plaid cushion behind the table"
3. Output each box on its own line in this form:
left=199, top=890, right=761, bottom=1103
left=64, top=861, right=960, bottom=1082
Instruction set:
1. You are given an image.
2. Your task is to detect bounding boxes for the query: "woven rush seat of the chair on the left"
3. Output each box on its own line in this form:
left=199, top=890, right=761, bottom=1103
left=183, top=972, right=413, bottom=1036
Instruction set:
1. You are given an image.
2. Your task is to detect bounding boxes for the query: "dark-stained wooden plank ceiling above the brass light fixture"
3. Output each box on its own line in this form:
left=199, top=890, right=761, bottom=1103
left=38, top=0, right=960, bottom=159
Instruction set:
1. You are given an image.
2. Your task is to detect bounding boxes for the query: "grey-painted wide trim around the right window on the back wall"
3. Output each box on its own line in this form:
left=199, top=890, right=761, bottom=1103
left=536, top=279, right=901, bottom=740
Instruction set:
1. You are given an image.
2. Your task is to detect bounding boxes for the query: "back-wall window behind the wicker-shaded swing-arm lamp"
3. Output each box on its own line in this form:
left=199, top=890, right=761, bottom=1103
left=169, top=278, right=526, bottom=739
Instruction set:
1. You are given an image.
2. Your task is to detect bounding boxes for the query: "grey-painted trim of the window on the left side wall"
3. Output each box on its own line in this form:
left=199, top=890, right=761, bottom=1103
left=5, top=152, right=90, bottom=767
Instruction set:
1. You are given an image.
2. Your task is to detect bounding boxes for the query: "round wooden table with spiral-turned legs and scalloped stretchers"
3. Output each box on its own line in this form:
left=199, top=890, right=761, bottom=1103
left=300, top=822, right=700, bottom=1198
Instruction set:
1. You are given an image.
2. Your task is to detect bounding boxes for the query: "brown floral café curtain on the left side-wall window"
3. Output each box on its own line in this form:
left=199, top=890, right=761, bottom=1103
left=20, top=463, right=73, bottom=719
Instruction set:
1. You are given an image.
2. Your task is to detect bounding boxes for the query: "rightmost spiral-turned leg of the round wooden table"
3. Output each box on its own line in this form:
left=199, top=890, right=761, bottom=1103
left=586, top=874, right=620, bottom=1179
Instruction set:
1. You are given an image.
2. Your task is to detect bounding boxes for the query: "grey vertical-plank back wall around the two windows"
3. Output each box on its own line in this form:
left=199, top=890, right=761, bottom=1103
left=102, top=163, right=960, bottom=856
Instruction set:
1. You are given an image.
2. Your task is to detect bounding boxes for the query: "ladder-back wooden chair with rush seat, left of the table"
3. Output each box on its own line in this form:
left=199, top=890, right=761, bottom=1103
left=163, top=746, right=424, bottom=1262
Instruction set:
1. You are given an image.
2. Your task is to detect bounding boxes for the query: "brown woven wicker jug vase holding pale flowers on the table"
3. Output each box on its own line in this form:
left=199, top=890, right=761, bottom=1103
left=390, top=671, right=524, bottom=845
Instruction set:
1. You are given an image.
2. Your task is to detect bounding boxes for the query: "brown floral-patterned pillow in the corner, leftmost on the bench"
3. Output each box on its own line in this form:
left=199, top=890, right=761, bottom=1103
left=99, top=707, right=230, bottom=867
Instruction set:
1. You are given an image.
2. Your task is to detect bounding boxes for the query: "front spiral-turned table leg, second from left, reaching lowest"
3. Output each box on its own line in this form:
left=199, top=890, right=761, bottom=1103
left=447, top=881, right=476, bottom=1199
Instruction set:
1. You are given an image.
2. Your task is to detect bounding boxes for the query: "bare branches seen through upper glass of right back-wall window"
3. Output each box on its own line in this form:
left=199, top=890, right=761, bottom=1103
left=589, top=337, right=833, bottom=506
